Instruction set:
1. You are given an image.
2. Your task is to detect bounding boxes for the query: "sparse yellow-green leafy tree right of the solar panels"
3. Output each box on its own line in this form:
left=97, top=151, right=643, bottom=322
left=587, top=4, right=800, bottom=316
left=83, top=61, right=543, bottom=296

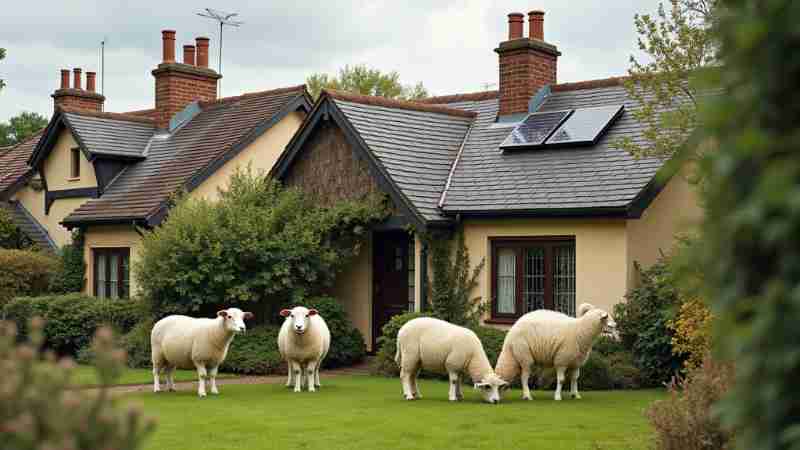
left=615, top=0, right=718, bottom=158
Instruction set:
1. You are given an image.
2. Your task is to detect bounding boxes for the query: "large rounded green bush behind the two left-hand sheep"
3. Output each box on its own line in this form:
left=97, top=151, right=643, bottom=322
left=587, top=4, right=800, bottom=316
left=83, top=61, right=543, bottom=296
left=135, top=167, right=387, bottom=323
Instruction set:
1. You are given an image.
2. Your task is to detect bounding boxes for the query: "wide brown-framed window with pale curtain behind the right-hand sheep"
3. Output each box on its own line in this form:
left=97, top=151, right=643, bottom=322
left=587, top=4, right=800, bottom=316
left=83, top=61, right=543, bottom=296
left=492, top=237, right=575, bottom=320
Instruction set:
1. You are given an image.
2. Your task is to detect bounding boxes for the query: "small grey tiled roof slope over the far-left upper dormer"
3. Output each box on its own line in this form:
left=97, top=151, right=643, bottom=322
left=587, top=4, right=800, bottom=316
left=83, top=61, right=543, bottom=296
left=64, top=110, right=155, bottom=158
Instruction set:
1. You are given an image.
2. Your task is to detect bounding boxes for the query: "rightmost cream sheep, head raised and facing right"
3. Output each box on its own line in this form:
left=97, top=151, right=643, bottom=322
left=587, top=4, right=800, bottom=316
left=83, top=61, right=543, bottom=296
left=495, top=303, right=613, bottom=400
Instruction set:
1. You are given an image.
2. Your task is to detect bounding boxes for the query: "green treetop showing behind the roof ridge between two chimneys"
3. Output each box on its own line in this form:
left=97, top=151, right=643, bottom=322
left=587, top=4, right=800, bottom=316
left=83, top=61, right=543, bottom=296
left=306, top=65, right=428, bottom=100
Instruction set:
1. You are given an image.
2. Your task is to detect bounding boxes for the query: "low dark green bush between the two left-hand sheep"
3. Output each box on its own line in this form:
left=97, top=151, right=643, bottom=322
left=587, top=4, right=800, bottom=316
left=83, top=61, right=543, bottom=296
left=220, top=325, right=285, bottom=375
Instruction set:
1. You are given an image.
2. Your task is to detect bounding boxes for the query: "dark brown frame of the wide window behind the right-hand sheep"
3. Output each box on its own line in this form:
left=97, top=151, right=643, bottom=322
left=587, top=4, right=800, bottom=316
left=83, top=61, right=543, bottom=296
left=489, top=236, right=577, bottom=324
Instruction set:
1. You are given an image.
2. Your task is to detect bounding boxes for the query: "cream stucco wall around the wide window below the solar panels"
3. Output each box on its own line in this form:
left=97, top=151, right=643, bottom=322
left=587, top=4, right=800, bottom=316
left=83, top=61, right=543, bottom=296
left=463, top=219, right=628, bottom=320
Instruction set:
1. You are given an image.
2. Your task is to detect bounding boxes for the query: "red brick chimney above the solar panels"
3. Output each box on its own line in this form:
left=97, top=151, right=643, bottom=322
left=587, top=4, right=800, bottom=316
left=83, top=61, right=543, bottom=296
left=494, top=11, right=561, bottom=116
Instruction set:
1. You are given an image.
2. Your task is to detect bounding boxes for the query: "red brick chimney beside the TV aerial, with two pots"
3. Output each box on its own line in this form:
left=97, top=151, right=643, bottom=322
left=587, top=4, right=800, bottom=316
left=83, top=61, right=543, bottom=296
left=152, top=30, right=222, bottom=129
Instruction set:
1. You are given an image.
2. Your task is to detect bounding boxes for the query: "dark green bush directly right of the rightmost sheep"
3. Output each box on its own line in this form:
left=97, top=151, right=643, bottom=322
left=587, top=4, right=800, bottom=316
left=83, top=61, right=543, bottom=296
left=614, top=259, right=685, bottom=387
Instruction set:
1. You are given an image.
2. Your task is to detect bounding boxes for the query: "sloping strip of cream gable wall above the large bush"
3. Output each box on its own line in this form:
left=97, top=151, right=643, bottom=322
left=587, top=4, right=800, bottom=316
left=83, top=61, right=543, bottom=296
left=189, top=112, right=305, bottom=200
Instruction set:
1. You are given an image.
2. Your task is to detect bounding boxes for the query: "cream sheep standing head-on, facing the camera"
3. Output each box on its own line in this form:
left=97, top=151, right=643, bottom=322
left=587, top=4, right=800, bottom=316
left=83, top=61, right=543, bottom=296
left=278, top=306, right=331, bottom=392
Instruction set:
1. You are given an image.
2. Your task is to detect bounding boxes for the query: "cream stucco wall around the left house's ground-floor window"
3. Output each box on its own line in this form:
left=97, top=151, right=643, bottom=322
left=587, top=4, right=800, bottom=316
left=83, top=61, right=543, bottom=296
left=83, top=225, right=142, bottom=296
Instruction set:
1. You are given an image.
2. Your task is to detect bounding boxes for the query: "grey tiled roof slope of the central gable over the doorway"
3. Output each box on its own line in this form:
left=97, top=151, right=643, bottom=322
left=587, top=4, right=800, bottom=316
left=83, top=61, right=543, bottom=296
left=326, top=94, right=475, bottom=221
